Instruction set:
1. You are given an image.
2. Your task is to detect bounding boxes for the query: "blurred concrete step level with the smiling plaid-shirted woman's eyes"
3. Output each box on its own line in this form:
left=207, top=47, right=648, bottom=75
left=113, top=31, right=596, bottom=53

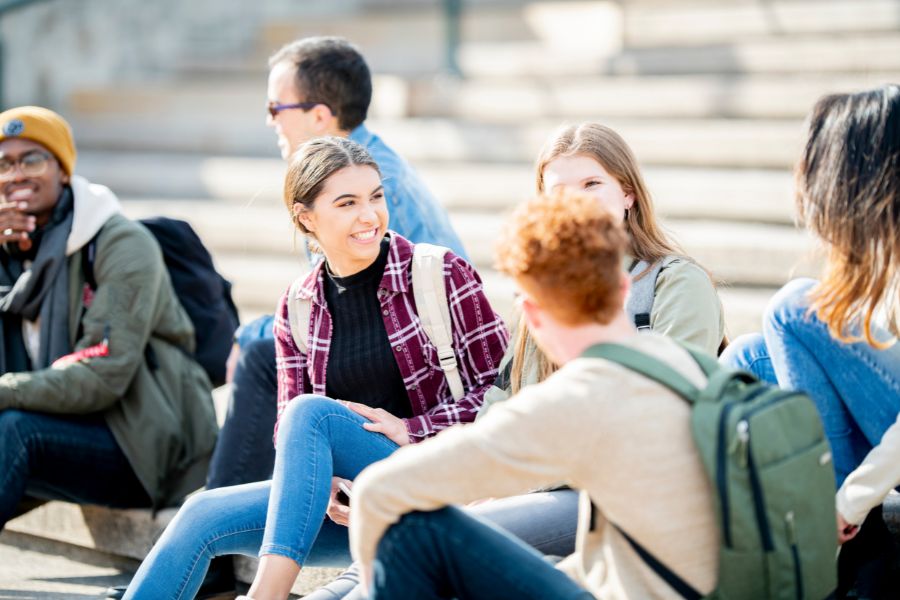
left=78, top=151, right=794, bottom=223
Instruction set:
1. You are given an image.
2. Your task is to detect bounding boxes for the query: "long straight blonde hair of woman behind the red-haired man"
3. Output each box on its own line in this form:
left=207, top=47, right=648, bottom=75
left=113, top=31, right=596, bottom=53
left=510, top=122, right=684, bottom=394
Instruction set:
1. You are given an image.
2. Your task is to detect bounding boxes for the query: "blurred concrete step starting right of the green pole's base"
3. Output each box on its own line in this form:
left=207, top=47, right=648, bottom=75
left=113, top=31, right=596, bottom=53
left=459, top=31, right=900, bottom=78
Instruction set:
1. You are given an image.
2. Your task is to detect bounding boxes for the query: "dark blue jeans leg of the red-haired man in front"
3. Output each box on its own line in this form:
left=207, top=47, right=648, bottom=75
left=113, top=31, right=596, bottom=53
left=369, top=507, right=593, bottom=600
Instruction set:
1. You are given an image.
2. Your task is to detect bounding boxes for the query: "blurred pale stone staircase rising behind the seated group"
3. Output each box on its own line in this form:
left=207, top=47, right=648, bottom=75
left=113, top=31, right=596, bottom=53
left=11, top=0, right=900, bottom=589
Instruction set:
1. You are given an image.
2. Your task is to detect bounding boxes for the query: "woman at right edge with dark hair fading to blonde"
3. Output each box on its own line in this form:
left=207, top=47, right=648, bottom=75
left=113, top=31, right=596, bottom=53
left=722, top=85, right=900, bottom=548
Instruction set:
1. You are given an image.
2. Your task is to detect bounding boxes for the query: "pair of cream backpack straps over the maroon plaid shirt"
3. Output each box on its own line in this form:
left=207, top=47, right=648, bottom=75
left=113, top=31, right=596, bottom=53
left=287, top=244, right=463, bottom=400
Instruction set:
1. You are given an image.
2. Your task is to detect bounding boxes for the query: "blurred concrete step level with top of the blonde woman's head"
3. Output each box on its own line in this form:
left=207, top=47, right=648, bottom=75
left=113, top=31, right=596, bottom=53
left=72, top=114, right=803, bottom=168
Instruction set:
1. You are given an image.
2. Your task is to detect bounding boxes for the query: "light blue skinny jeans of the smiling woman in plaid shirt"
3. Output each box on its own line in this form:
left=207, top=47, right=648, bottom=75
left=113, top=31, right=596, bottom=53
left=125, top=395, right=397, bottom=600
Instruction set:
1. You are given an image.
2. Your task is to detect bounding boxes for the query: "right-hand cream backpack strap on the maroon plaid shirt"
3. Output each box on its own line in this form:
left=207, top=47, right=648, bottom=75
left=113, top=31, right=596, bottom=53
left=412, top=244, right=464, bottom=400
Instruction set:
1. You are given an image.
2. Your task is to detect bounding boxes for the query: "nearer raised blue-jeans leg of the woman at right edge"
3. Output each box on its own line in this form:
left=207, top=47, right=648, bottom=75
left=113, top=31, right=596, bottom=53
left=763, top=279, right=900, bottom=485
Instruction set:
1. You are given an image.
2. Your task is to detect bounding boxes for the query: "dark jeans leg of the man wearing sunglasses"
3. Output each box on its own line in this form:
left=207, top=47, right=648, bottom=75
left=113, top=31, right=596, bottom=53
left=206, top=338, right=278, bottom=489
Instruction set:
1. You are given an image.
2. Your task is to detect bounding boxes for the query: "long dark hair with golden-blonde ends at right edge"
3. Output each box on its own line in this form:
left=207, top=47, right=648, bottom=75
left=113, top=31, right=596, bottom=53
left=795, top=85, right=900, bottom=349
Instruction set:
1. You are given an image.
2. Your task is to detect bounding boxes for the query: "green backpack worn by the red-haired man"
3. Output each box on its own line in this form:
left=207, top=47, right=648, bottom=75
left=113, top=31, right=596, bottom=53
left=582, top=344, right=837, bottom=600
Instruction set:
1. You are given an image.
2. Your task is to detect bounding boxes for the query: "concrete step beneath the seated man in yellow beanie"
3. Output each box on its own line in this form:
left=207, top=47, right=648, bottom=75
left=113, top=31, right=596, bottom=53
left=5, top=502, right=343, bottom=597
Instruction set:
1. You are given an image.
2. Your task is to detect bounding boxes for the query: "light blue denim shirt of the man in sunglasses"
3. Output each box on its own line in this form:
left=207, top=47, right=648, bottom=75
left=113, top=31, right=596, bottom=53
left=236, top=124, right=469, bottom=347
